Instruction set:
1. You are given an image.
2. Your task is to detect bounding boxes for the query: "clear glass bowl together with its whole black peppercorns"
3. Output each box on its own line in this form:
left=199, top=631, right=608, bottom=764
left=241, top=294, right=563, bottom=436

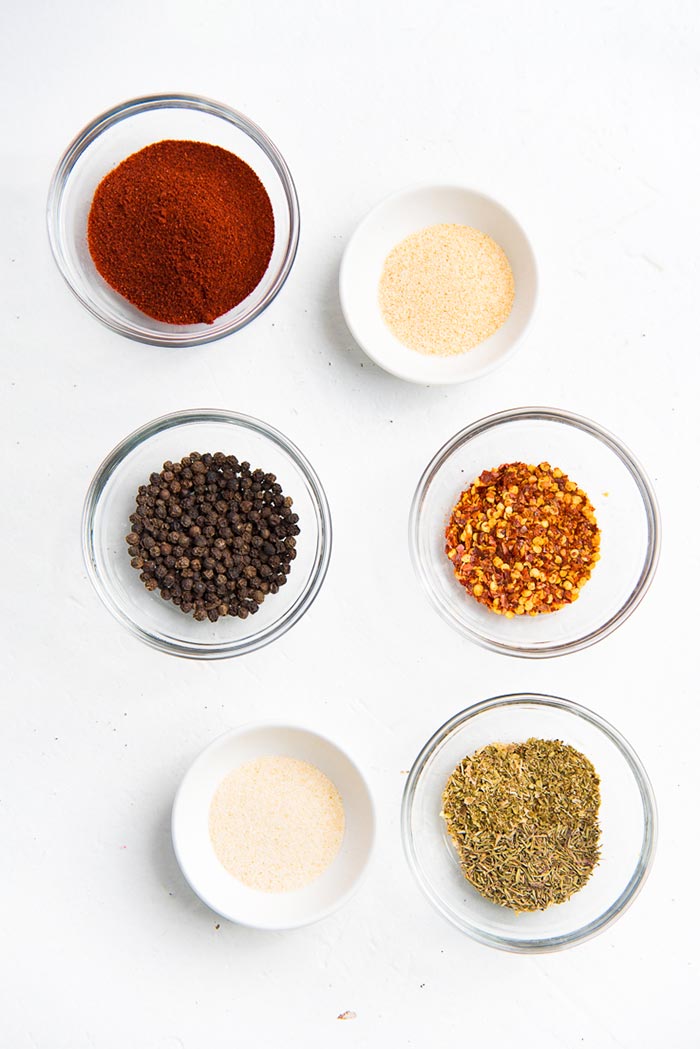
left=83, top=410, right=332, bottom=659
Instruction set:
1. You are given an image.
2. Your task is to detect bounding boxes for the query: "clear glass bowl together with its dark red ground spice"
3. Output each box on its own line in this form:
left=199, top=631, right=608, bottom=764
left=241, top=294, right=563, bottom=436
left=46, top=94, right=299, bottom=346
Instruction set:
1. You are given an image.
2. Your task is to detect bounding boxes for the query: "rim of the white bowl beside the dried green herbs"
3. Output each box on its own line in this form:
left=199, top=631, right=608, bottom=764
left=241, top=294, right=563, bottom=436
left=170, top=719, right=377, bottom=932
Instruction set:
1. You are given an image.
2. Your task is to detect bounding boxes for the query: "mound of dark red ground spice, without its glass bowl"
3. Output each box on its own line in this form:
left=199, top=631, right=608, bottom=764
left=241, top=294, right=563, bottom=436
left=87, top=140, right=275, bottom=324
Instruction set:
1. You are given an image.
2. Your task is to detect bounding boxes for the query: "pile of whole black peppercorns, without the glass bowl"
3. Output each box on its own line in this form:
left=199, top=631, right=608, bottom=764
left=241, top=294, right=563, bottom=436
left=126, top=452, right=299, bottom=623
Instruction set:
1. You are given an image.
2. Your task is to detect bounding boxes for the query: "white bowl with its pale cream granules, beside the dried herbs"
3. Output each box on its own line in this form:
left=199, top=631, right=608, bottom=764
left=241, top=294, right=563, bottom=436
left=172, top=723, right=375, bottom=929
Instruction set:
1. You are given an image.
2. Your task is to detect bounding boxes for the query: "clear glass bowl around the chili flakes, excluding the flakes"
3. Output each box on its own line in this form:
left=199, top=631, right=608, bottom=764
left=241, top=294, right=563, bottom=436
left=408, top=408, right=660, bottom=658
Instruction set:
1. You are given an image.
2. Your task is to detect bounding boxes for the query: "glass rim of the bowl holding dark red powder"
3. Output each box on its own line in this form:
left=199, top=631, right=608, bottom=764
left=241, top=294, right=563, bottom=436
left=46, top=93, right=300, bottom=347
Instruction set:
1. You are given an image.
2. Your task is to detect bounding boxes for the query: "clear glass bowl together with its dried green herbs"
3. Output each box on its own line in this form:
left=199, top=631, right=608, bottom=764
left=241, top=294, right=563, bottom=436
left=402, top=693, right=656, bottom=954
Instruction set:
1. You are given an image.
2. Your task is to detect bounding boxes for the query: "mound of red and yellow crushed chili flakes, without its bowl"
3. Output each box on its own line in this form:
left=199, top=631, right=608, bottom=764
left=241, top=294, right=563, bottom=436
left=445, top=463, right=600, bottom=619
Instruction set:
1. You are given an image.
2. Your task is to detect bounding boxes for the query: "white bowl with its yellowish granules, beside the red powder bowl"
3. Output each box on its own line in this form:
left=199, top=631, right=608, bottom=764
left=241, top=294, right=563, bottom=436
left=339, top=185, right=537, bottom=385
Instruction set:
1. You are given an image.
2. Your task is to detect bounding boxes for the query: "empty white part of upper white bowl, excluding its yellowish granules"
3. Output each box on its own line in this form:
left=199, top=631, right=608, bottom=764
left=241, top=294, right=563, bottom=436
left=340, top=186, right=537, bottom=386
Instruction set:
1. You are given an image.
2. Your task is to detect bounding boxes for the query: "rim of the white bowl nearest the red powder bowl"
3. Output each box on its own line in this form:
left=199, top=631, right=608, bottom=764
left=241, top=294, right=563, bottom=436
left=338, top=179, right=539, bottom=386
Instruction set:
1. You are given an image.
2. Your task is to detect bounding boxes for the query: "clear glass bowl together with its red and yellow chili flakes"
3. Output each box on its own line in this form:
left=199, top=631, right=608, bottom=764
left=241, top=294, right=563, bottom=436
left=408, top=408, right=661, bottom=658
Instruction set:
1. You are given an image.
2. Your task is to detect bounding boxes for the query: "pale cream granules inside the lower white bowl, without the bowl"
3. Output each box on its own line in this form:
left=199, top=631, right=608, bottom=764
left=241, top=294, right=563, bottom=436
left=209, top=756, right=345, bottom=893
